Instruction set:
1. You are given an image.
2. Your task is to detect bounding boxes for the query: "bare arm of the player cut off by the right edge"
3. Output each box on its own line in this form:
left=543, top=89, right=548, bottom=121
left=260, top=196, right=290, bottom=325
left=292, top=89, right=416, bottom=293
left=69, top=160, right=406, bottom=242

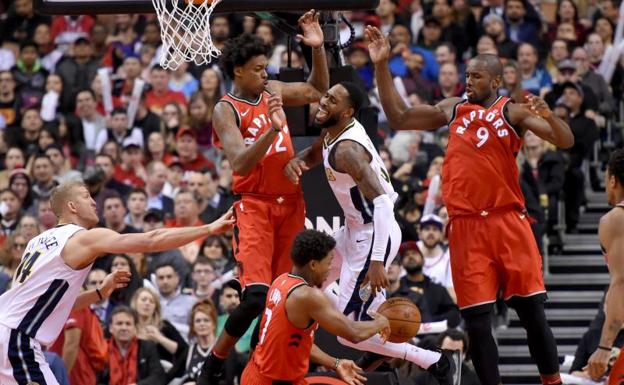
left=587, top=210, right=624, bottom=381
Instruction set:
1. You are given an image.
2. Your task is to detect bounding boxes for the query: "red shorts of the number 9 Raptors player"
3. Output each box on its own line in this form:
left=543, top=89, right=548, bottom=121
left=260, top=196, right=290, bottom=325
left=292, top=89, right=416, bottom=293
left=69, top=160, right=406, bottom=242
left=448, top=210, right=546, bottom=309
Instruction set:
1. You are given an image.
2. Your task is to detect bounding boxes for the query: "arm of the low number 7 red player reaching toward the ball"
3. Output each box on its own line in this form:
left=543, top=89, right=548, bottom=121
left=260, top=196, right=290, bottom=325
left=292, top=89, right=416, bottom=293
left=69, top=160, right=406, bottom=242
left=298, top=288, right=390, bottom=343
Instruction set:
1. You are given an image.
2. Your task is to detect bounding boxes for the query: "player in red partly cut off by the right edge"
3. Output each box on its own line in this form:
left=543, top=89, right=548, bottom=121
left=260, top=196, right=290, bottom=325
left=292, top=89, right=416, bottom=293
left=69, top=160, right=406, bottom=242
left=587, top=149, right=624, bottom=385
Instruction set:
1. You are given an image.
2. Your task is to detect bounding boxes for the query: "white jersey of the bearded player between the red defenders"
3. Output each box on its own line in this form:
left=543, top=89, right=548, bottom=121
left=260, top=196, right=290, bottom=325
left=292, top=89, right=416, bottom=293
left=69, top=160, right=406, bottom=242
left=323, top=119, right=398, bottom=226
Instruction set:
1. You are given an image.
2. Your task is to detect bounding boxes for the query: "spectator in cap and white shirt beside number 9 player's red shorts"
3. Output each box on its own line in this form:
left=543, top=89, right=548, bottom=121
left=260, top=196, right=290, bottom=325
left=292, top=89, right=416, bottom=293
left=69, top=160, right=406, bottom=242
left=417, top=214, right=455, bottom=297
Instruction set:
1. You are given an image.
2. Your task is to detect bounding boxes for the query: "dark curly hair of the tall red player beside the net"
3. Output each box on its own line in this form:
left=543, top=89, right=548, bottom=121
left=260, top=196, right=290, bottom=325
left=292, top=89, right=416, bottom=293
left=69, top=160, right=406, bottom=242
left=220, top=34, right=270, bottom=80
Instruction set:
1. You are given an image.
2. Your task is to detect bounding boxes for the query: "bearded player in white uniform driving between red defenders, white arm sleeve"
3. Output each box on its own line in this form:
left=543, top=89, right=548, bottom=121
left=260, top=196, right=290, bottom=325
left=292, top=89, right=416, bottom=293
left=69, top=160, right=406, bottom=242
left=284, top=82, right=454, bottom=384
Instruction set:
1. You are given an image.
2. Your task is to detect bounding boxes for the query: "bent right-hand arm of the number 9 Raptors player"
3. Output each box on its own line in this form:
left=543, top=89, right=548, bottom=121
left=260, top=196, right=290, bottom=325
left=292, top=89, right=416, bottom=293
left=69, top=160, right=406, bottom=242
left=508, top=95, right=574, bottom=148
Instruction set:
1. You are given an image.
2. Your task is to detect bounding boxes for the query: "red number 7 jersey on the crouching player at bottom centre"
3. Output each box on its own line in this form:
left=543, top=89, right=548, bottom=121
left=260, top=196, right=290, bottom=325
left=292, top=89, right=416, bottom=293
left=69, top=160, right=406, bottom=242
left=252, top=273, right=318, bottom=382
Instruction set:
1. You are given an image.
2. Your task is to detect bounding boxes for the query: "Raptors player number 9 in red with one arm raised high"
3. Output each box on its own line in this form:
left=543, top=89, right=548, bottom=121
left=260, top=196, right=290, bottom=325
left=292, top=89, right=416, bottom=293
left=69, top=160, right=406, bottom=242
left=366, top=27, right=574, bottom=385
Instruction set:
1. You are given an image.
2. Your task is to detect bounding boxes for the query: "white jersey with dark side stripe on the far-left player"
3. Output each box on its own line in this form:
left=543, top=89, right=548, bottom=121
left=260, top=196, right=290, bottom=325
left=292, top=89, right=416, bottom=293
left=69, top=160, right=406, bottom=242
left=0, top=224, right=91, bottom=345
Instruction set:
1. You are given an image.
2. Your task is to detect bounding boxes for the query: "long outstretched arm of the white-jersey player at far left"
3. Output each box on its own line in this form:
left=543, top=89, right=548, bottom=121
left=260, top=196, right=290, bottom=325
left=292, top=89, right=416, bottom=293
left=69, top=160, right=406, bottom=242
left=62, top=209, right=234, bottom=269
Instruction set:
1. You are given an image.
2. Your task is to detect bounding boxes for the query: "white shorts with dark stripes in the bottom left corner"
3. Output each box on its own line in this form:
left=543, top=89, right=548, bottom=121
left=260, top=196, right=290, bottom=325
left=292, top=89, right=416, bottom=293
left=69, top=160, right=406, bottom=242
left=0, top=325, right=58, bottom=385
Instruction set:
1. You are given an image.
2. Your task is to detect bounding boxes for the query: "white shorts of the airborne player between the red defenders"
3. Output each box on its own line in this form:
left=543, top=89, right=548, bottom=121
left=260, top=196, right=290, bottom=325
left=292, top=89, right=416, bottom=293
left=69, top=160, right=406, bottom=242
left=325, top=221, right=401, bottom=321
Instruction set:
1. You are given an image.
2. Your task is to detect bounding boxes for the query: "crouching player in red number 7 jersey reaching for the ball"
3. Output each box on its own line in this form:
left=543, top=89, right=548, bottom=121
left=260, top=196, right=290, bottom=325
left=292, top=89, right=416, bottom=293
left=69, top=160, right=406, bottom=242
left=241, top=230, right=390, bottom=385
